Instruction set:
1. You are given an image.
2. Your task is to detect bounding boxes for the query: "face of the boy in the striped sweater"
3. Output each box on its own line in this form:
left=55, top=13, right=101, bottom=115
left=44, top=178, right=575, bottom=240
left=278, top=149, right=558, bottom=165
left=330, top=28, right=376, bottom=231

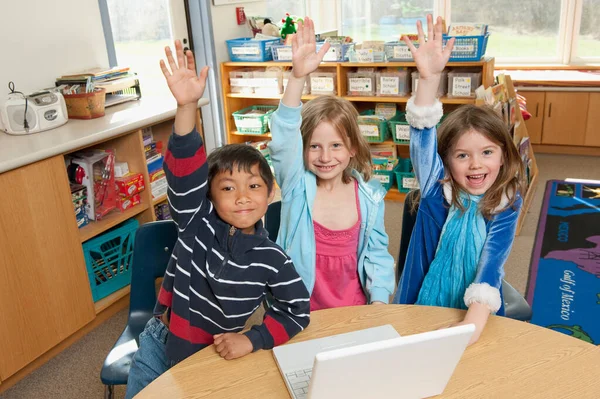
left=210, top=164, right=275, bottom=234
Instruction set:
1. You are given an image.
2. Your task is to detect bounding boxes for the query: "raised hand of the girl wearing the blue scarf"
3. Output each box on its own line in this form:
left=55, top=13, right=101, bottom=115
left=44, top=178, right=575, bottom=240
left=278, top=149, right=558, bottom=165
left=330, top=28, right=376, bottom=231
left=402, top=14, right=454, bottom=79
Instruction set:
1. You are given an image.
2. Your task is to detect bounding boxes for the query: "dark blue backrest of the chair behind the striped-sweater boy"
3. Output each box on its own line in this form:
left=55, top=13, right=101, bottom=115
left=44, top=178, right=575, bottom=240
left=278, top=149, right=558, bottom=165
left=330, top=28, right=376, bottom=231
left=127, top=220, right=177, bottom=332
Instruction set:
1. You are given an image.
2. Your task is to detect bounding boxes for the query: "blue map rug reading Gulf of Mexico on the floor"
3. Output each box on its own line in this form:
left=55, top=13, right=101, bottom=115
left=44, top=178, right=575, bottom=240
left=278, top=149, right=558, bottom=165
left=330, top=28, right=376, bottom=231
left=527, top=180, right=600, bottom=345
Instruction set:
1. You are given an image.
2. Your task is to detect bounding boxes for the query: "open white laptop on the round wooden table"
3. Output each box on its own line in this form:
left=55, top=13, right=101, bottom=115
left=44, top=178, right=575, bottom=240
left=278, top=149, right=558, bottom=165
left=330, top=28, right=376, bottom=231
left=273, top=324, right=475, bottom=399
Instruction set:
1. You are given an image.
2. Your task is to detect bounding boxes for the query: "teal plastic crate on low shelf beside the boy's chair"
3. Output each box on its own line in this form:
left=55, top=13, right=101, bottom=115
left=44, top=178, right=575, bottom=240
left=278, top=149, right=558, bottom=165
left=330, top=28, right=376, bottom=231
left=83, top=219, right=139, bottom=302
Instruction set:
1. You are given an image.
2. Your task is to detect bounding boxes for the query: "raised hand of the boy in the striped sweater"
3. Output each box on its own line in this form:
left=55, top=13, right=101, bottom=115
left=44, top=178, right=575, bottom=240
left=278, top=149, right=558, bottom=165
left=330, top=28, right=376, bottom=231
left=160, top=40, right=208, bottom=106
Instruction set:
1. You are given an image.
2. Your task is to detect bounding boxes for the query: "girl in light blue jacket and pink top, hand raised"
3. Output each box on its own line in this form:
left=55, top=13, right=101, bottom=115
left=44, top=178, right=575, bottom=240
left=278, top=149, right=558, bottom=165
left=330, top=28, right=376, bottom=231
left=269, top=18, right=395, bottom=310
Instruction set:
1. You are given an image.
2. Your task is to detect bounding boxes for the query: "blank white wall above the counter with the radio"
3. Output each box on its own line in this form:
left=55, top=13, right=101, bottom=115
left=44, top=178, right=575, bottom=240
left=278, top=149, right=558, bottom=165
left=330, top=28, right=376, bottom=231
left=0, top=0, right=108, bottom=96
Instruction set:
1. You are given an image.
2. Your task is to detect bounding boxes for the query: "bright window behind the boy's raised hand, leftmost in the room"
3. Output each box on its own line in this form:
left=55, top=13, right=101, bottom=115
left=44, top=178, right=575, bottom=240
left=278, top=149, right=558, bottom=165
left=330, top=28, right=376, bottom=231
left=100, top=0, right=189, bottom=96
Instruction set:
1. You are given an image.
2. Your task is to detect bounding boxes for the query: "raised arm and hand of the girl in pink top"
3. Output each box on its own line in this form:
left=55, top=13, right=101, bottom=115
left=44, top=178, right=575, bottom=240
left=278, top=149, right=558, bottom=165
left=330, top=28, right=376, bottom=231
left=269, top=17, right=329, bottom=201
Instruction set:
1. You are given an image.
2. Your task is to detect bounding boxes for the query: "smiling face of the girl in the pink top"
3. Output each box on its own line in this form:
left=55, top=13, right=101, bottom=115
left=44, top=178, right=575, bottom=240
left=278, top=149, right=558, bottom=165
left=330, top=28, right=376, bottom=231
left=306, top=121, right=354, bottom=181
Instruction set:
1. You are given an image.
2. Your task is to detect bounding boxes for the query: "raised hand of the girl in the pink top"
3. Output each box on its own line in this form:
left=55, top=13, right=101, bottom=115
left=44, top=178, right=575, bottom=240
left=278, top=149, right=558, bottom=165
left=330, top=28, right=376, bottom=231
left=292, top=17, right=330, bottom=78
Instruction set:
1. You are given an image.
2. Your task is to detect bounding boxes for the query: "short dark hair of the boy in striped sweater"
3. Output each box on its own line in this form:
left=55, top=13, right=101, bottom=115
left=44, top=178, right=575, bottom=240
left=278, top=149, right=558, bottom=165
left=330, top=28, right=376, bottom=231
left=207, top=144, right=275, bottom=194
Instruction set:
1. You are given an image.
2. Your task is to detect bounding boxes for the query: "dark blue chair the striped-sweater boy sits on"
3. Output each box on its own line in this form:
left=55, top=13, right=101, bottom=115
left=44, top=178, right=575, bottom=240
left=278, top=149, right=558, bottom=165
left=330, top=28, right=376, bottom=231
left=100, top=221, right=177, bottom=399
